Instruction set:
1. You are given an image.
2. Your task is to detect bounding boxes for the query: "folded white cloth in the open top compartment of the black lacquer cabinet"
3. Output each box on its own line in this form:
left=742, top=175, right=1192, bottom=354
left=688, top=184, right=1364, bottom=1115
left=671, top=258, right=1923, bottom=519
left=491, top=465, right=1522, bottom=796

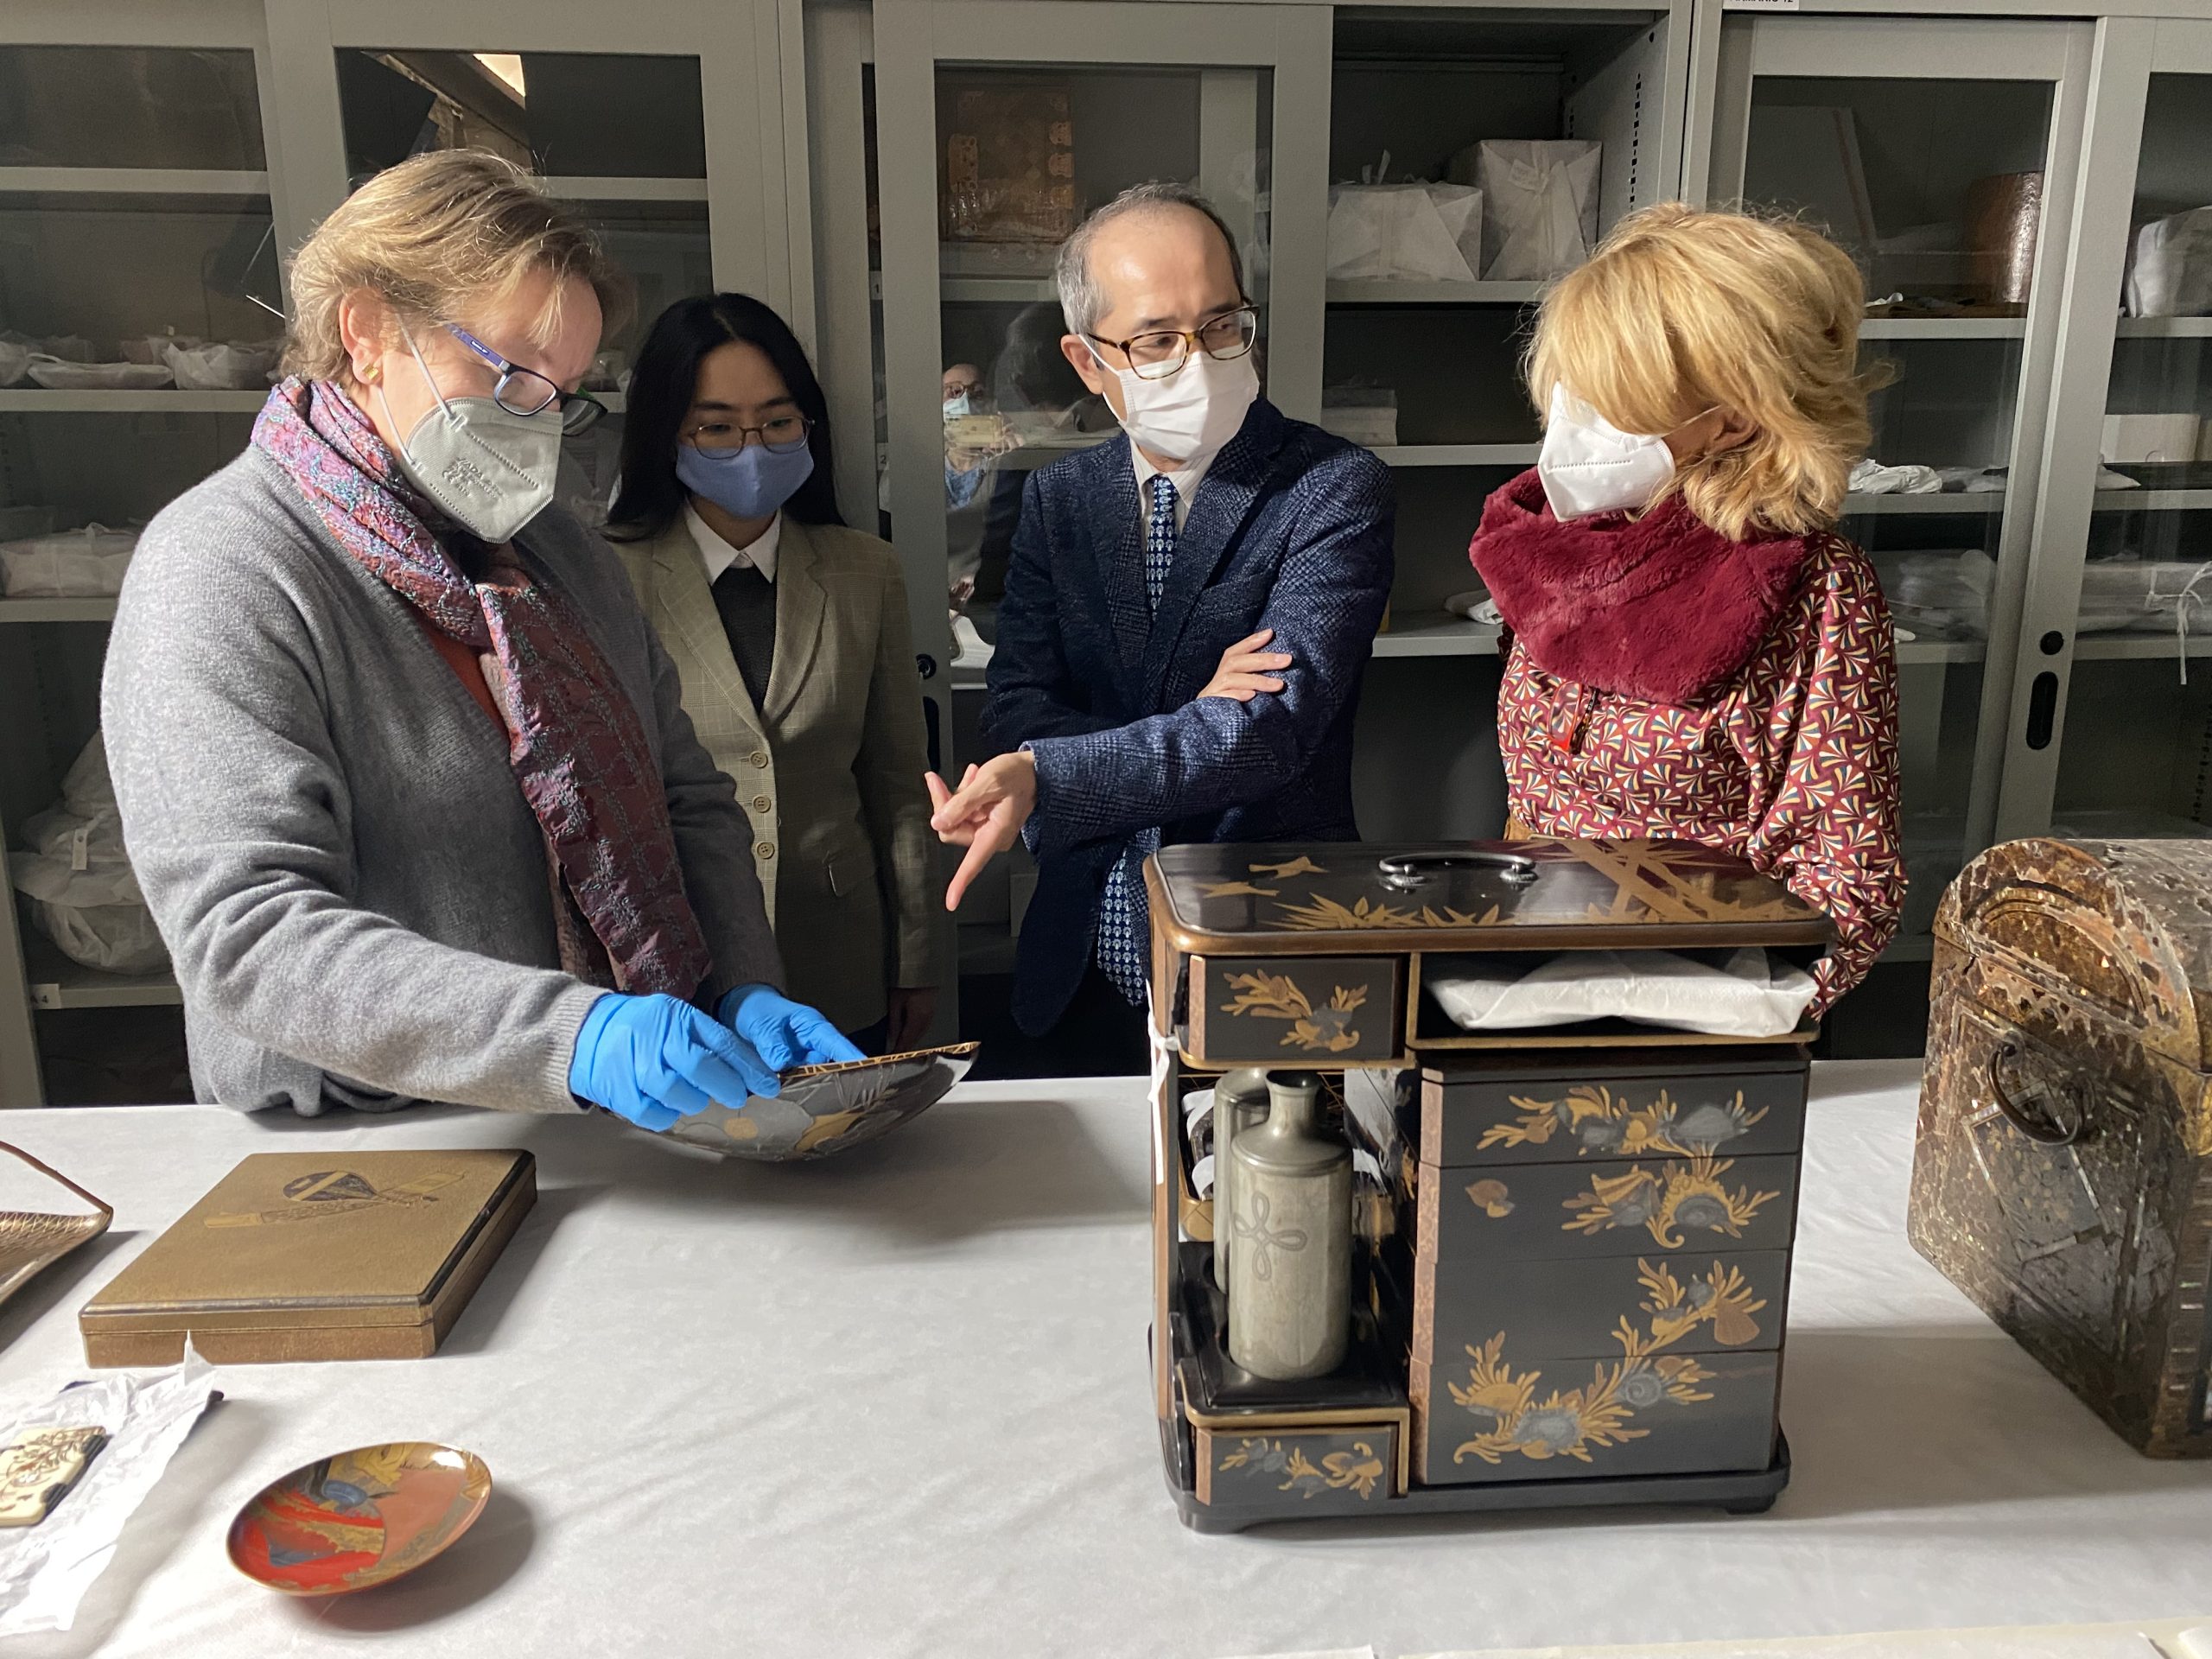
left=1427, top=947, right=1814, bottom=1038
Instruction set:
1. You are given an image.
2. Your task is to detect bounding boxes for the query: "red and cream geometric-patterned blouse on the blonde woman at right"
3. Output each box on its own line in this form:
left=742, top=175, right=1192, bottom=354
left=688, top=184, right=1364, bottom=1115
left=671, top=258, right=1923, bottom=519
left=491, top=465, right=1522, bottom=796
left=1497, top=536, right=1904, bottom=1015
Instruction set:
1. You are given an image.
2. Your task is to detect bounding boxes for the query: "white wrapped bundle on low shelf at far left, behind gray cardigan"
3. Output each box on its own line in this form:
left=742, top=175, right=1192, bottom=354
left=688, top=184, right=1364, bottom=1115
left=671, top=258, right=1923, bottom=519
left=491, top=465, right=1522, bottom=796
left=13, top=732, right=168, bottom=973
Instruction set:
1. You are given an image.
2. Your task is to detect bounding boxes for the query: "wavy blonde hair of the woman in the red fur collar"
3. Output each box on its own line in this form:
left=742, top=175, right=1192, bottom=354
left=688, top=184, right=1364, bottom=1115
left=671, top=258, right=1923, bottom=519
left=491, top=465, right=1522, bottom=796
left=1526, top=201, right=1880, bottom=540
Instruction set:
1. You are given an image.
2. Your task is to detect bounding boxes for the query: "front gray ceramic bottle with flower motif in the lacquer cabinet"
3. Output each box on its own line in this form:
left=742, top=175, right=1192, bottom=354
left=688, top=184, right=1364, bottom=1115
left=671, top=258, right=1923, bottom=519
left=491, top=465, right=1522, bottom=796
left=1230, top=1071, right=1351, bottom=1382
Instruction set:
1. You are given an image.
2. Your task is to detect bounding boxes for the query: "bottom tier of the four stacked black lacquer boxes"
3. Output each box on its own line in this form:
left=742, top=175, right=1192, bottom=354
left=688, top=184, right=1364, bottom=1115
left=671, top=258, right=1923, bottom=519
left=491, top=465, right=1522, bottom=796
left=1409, top=1343, right=1781, bottom=1486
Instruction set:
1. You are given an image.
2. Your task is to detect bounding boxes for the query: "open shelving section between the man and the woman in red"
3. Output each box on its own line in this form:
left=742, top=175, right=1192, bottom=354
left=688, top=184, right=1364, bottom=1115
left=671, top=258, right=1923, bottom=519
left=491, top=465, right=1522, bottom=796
left=1320, top=7, right=1688, bottom=838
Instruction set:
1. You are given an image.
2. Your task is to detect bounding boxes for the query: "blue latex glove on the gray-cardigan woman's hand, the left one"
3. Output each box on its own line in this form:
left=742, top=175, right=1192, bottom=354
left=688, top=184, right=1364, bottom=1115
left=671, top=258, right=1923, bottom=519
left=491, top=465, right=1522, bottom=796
left=569, top=993, right=783, bottom=1133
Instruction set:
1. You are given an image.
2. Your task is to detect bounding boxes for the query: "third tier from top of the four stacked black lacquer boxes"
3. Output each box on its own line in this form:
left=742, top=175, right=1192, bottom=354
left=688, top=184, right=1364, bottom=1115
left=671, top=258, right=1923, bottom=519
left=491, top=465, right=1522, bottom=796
left=1411, top=1249, right=1789, bottom=1363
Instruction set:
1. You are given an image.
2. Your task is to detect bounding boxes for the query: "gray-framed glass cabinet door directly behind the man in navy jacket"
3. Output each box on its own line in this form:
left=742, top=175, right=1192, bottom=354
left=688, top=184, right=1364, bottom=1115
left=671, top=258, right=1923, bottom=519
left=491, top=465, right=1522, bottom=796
left=869, top=0, right=1327, bottom=971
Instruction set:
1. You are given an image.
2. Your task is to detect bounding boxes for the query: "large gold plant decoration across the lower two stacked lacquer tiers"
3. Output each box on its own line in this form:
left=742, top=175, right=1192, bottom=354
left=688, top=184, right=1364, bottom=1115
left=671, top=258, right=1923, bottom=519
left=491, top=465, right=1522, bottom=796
left=1446, top=1259, right=1765, bottom=1465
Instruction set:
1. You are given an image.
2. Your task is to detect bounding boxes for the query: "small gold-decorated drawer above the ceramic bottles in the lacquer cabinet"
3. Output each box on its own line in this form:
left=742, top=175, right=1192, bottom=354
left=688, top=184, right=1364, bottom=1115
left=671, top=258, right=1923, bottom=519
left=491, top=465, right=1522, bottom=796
left=1184, top=956, right=1405, bottom=1066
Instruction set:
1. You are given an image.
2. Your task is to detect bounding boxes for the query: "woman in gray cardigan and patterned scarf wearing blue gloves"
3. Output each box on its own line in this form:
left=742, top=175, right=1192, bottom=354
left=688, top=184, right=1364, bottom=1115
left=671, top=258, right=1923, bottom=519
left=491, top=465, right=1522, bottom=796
left=102, top=150, right=858, bottom=1130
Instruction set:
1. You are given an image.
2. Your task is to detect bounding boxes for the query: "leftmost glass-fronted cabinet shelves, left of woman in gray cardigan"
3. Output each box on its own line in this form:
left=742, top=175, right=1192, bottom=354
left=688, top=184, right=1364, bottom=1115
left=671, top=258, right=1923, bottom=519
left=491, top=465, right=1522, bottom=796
left=0, top=44, right=283, bottom=1102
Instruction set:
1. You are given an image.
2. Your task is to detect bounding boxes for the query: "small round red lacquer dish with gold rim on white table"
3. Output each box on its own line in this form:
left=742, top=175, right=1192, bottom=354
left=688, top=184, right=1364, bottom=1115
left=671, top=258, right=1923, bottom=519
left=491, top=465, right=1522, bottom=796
left=230, top=1440, right=491, bottom=1595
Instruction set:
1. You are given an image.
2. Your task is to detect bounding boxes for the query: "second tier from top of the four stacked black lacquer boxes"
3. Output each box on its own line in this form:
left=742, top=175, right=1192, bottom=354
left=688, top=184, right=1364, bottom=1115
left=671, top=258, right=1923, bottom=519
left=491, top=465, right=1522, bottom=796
left=1414, top=1153, right=1798, bottom=1272
